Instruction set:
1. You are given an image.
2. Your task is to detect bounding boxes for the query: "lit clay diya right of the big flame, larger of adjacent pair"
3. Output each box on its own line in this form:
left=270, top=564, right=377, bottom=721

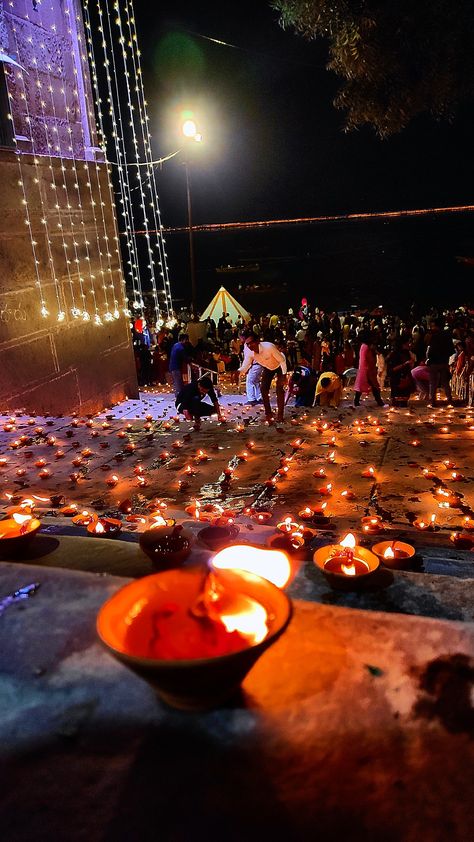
left=313, top=533, right=379, bottom=588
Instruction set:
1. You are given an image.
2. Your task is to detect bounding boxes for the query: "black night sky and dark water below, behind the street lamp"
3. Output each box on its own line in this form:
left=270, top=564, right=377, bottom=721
left=131, top=0, right=474, bottom=306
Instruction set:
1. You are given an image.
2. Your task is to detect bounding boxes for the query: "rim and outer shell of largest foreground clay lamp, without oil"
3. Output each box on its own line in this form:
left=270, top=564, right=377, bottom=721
left=97, top=567, right=292, bottom=710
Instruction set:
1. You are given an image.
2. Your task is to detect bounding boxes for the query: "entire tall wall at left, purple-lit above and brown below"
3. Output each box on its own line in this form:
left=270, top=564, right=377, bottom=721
left=0, top=0, right=137, bottom=413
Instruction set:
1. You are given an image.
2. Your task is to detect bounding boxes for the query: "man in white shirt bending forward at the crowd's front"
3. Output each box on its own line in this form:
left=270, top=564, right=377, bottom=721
left=239, top=334, right=286, bottom=423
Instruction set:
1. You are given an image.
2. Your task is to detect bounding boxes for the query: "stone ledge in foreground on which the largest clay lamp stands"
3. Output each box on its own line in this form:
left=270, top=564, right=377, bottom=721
left=0, top=564, right=474, bottom=842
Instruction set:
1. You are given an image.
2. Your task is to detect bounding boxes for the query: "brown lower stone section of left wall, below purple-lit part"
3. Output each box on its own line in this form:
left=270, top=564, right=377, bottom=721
left=0, top=150, right=138, bottom=413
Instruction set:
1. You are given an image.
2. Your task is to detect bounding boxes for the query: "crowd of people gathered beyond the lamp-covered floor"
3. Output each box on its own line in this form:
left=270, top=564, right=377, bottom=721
left=134, top=299, right=474, bottom=422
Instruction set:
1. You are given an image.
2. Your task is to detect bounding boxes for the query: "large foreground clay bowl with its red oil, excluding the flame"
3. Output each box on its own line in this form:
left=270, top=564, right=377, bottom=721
left=97, top=568, right=292, bottom=710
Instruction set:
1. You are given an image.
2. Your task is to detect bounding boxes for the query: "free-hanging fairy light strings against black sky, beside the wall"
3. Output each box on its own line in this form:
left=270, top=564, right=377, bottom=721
left=83, top=0, right=173, bottom=325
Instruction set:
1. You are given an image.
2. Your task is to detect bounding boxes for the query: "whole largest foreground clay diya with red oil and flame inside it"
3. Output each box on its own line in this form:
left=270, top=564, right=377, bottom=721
left=97, top=569, right=291, bottom=710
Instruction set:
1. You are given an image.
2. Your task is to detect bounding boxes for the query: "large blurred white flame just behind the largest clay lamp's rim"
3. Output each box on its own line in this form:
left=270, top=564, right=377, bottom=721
left=211, top=544, right=291, bottom=588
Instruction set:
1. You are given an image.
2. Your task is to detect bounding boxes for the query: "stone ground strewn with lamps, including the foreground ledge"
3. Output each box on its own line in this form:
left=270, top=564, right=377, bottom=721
left=0, top=388, right=474, bottom=842
